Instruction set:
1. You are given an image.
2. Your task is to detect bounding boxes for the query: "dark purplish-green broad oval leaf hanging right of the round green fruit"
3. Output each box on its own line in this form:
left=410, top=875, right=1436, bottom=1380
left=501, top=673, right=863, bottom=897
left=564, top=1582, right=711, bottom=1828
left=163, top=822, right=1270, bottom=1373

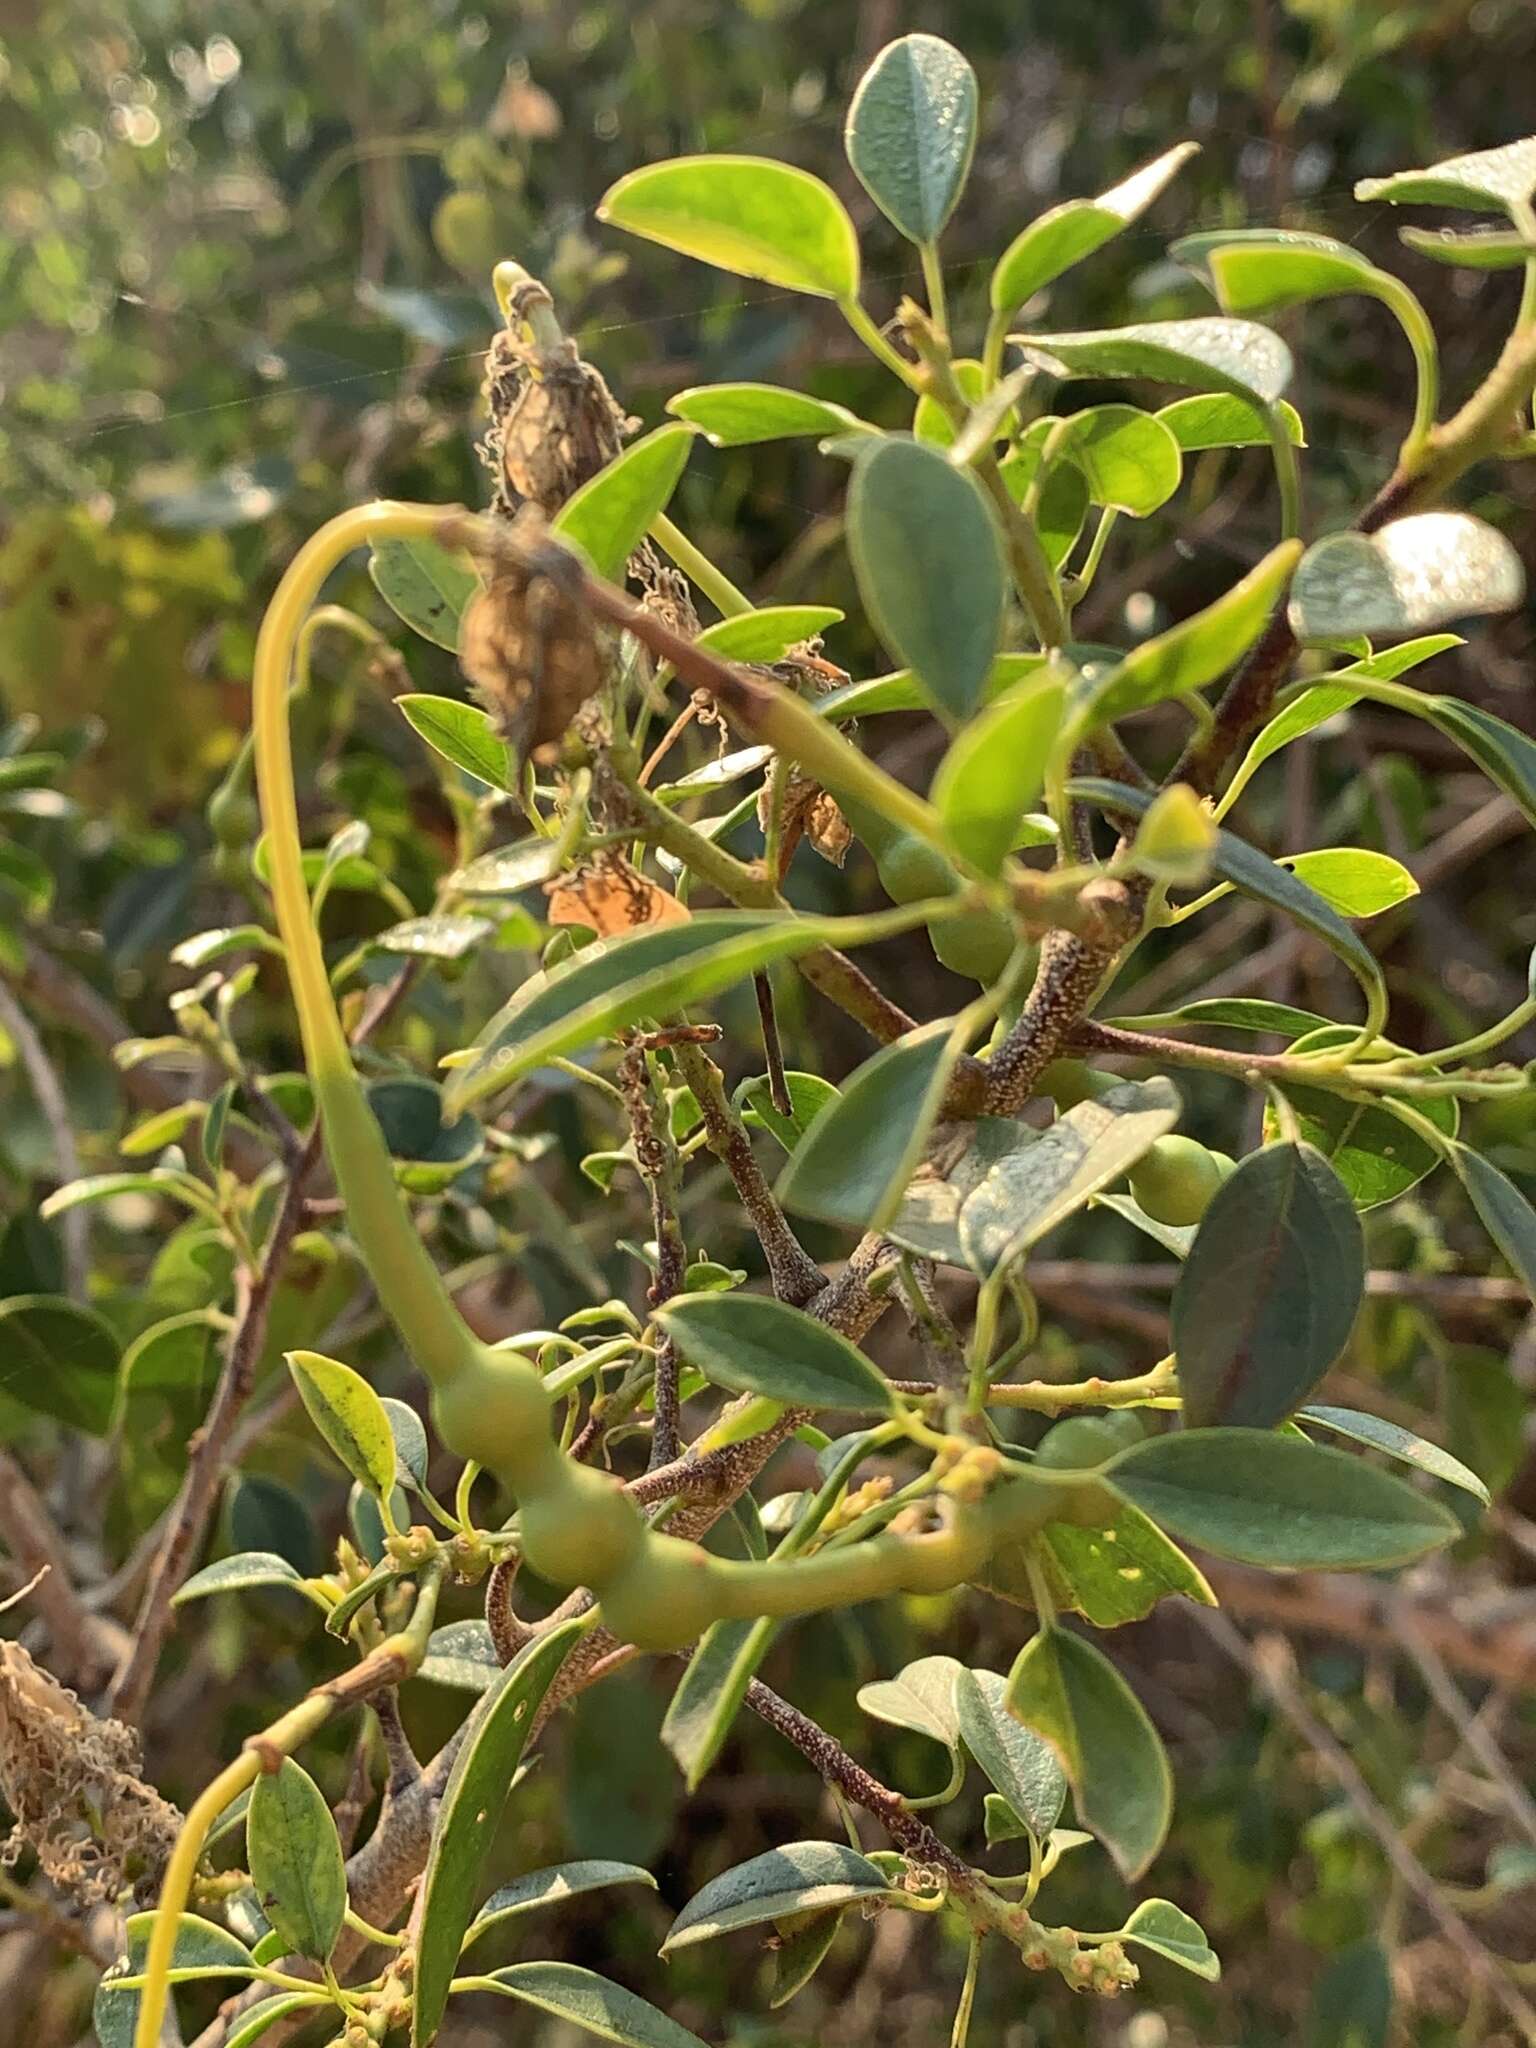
left=1174, top=1145, right=1366, bottom=1430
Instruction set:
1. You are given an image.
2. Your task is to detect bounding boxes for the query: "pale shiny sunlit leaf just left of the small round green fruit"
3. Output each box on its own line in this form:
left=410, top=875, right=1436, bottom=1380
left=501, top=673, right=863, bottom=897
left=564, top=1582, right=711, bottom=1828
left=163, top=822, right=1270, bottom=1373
left=958, top=1075, right=1180, bottom=1278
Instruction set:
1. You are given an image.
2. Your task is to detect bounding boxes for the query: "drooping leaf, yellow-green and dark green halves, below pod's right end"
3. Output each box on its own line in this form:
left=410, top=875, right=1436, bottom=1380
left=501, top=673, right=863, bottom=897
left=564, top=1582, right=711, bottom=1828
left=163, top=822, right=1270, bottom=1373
left=1006, top=1628, right=1174, bottom=1880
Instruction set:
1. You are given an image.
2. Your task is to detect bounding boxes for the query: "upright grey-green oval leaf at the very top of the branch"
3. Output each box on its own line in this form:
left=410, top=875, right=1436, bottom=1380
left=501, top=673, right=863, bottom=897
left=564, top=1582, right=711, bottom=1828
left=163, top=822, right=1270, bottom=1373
left=844, top=35, right=977, bottom=244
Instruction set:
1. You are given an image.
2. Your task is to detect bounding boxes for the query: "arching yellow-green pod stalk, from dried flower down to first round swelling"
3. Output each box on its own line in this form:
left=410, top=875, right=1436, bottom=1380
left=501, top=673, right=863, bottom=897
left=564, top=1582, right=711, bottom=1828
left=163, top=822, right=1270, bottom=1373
left=252, top=504, right=493, bottom=1386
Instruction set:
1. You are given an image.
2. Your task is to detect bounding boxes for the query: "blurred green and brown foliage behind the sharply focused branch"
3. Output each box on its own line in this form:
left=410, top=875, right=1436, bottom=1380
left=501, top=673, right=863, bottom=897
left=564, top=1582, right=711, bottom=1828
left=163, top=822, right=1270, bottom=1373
left=0, top=0, right=1536, bottom=2048
